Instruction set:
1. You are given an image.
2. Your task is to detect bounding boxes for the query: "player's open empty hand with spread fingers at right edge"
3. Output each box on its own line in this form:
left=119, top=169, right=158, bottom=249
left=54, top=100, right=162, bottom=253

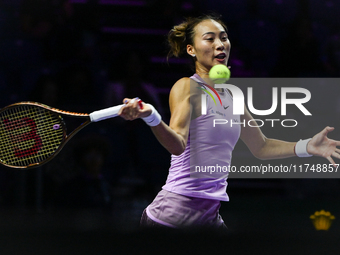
left=307, top=127, right=340, bottom=167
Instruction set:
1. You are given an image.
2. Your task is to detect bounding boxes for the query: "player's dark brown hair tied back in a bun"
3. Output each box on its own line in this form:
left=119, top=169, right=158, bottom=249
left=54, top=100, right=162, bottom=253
left=168, top=14, right=227, bottom=58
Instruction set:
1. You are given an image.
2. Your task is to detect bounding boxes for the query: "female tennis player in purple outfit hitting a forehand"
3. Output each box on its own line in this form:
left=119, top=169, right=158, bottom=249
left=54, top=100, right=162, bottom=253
left=119, top=15, right=340, bottom=228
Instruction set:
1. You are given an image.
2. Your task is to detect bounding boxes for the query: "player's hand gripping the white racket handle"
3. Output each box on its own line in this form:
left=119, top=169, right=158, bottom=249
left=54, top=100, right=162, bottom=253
left=118, top=98, right=151, bottom=120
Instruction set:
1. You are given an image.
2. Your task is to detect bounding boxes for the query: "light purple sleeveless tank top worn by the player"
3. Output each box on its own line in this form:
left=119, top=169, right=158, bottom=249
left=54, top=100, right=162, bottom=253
left=162, top=74, right=241, bottom=201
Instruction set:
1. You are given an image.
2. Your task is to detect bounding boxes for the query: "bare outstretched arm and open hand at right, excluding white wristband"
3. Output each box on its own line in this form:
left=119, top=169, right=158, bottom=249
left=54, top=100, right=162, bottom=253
left=241, top=107, right=340, bottom=164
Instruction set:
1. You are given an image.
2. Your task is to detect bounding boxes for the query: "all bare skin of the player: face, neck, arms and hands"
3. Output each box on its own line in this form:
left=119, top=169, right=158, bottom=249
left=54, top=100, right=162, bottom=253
left=119, top=20, right=340, bottom=165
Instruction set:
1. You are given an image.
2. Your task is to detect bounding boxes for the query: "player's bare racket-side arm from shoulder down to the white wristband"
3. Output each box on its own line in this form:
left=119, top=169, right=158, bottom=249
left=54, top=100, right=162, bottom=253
left=151, top=78, right=192, bottom=155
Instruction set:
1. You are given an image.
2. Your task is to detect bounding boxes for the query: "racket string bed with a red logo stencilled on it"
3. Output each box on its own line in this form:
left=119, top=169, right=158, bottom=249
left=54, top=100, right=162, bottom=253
left=0, top=105, right=65, bottom=167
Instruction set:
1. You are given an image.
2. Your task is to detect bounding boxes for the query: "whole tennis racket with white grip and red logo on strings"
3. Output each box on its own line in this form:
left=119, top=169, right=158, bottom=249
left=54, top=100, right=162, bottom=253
left=0, top=102, right=127, bottom=169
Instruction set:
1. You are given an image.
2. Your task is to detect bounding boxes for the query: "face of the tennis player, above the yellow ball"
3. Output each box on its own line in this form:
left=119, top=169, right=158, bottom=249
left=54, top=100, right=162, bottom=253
left=188, top=20, right=231, bottom=72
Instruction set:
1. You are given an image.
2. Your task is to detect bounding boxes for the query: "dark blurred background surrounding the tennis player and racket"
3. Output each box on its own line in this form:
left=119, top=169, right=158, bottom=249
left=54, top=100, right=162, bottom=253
left=0, top=0, right=340, bottom=254
